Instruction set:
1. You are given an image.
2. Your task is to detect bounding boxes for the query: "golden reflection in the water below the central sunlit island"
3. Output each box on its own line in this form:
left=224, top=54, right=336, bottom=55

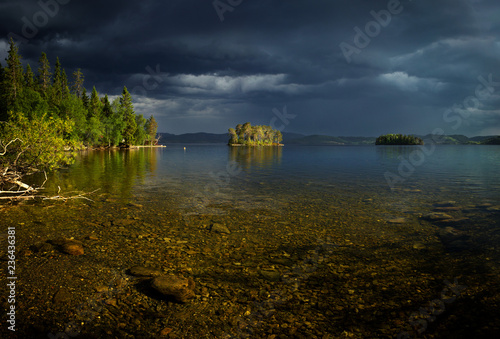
left=229, top=146, right=282, bottom=170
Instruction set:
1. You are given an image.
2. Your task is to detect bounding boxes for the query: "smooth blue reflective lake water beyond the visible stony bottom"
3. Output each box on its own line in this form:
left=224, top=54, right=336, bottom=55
left=42, top=145, right=500, bottom=207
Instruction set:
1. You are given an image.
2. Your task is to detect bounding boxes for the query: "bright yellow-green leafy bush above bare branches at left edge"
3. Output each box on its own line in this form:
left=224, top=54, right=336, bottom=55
left=0, top=114, right=75, bottom=173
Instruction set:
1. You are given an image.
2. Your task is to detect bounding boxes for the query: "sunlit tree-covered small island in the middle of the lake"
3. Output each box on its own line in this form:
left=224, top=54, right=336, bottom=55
left=228, top=122, right=283, bottom=146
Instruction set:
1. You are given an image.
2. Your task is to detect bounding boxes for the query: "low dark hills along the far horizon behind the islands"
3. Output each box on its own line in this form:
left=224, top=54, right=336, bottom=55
left=159, top=132, right=500, bottom=146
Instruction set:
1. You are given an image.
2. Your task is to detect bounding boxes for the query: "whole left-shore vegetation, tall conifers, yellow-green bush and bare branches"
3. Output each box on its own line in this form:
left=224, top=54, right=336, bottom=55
left=0, top=38, right=159, bottom=200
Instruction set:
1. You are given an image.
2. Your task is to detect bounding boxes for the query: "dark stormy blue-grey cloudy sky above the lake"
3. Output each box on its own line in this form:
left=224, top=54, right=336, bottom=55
left=0, top=0, right=500, bottom=136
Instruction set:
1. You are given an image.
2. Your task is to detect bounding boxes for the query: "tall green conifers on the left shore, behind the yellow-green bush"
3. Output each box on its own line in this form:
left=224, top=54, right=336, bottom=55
left=0, top=39, right=158, bottom=159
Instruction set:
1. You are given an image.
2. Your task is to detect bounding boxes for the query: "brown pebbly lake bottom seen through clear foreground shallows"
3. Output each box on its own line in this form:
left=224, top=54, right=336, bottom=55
left=0, top=188, right=500, bottom=339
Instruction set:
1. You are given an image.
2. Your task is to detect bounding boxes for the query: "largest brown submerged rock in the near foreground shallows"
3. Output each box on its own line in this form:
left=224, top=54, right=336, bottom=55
left=151, top=275, right=195, bottom=303
